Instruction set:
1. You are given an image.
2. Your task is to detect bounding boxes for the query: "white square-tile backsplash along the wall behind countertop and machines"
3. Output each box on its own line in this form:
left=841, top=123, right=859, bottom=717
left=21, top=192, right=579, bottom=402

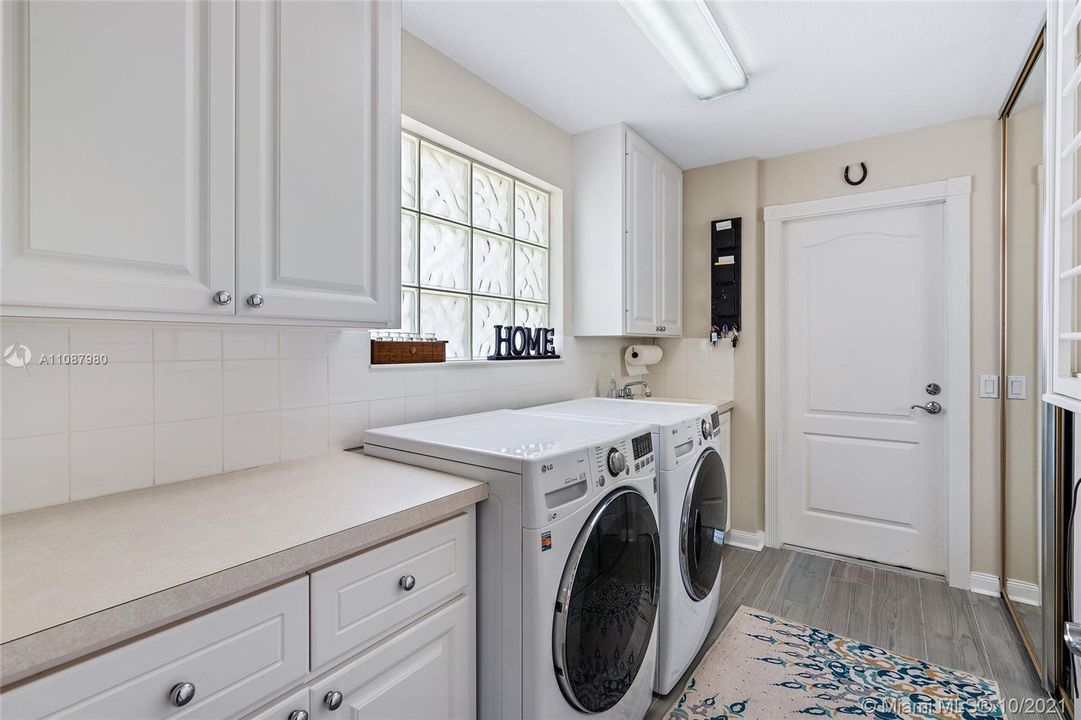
left=0, top=318, right=635, bottom=512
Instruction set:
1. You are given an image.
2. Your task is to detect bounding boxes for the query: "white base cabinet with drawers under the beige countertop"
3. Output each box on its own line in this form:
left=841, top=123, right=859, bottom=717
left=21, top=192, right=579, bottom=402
left=0, top=511, right=477, bottom=720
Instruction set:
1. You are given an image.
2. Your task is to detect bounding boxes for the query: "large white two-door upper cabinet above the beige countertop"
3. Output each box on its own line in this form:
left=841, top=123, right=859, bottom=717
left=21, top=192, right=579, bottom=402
left=0, top=0, right=401, bottom=326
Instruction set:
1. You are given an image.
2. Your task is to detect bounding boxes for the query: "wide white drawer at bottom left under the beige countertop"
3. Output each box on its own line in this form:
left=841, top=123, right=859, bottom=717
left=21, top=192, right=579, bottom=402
left=0, top=577, right=308, bottom=720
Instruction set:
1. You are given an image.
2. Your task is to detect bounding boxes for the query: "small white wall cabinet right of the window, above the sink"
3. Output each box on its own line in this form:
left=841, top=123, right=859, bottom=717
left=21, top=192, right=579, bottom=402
left=574, top=124, right=683, bottom=336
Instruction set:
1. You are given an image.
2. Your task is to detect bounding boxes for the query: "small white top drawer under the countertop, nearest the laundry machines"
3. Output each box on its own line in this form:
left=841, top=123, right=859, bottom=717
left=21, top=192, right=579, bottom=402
left=311, top=515, right=473, bottom=669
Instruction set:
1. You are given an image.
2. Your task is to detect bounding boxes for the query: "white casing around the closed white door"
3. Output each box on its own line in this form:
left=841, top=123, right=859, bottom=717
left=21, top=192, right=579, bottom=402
left=763, top=176, right=972, bottom=589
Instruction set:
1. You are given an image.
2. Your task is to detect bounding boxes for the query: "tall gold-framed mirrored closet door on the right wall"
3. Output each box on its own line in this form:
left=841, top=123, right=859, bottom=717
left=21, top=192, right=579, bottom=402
left=999, top=30, right=1060, bottom=688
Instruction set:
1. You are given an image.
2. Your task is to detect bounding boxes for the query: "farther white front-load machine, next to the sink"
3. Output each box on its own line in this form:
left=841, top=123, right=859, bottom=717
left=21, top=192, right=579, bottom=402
left=528, top=398, right=731, bottom=694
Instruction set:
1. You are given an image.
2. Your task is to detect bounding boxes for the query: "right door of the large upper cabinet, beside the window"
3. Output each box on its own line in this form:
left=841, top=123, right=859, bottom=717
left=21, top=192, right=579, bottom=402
left=238, top=0, right=401, bottom=326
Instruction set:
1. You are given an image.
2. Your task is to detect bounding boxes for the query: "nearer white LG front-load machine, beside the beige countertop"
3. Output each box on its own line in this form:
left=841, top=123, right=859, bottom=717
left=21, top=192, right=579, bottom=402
left=364, top=411, right=663, bottom=720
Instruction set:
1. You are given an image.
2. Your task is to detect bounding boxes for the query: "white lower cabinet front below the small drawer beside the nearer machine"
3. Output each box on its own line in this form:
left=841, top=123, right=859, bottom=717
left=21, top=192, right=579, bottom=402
left=309, top=597, right=477, bottom=720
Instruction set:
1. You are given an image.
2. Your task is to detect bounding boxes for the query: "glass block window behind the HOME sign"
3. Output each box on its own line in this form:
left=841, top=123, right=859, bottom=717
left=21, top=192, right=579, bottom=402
left=401, top=133, right=550, bottom=360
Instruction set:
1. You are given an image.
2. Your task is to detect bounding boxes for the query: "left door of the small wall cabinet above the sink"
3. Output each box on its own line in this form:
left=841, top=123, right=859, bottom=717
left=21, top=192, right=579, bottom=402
left=624, top=133, right=660, bottom=335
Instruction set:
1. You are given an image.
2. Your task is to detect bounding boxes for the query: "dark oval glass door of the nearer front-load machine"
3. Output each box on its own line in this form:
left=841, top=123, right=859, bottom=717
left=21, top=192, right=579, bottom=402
left=555, top=489, right=660, bottom=712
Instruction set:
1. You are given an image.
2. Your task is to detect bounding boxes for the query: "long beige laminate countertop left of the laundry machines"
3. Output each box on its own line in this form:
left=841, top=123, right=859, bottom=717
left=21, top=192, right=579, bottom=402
left=0, top=452, right=488, bottom=684
